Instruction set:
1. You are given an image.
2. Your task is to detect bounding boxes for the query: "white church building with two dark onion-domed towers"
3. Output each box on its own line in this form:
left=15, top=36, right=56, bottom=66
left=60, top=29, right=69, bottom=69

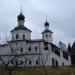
left=0, top=12, right=71, bottom=66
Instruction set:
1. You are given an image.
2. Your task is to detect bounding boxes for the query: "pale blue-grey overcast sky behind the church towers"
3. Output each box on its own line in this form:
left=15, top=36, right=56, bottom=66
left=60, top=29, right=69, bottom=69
left=0, top=0, right=75, bottom=44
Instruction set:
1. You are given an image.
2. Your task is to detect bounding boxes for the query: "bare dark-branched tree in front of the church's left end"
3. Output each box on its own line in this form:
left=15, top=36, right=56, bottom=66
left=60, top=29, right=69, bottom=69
left=0, top=43, right=21, bottom=75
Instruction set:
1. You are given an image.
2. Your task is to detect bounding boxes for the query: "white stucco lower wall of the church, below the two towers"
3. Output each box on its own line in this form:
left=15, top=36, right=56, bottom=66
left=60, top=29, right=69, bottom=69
left=0, top=40, right=71, bottom=66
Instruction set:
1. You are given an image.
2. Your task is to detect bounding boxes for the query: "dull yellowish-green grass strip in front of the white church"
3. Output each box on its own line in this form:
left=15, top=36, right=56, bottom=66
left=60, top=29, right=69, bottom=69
left=0, top=67, right=75, bottom=75
